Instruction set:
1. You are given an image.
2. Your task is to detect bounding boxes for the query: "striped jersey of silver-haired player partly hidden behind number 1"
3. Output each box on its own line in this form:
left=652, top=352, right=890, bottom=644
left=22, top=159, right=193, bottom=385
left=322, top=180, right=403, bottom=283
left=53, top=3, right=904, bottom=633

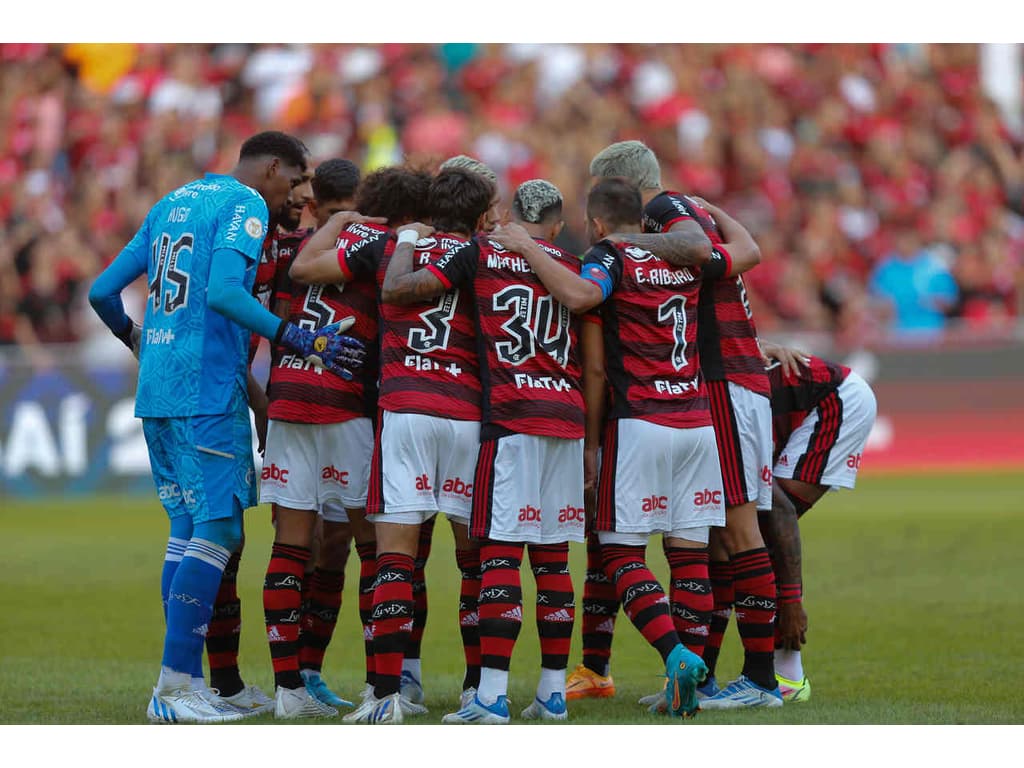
left=643, top=191, right=769, bottom=396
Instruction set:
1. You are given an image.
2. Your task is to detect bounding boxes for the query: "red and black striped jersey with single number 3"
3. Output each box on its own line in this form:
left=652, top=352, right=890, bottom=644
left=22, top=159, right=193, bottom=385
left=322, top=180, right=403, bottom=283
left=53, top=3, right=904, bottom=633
left=377, top=232, right=480, bottom=421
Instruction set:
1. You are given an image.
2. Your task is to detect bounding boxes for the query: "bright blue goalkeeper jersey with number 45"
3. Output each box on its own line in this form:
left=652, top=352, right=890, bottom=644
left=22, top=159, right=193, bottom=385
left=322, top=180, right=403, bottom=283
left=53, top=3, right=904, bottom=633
left=125, top=173, right=267, bottom=417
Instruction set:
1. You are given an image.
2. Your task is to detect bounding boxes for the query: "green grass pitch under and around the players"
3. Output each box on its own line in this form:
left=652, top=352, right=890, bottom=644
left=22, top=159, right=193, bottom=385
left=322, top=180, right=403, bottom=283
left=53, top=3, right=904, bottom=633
left=0, top=474, right=1024, bottom=725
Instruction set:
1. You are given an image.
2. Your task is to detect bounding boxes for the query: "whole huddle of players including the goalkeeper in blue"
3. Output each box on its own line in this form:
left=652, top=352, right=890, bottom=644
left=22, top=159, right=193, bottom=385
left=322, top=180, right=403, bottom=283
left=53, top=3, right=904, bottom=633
left=89, top=132, right=876, bottom=724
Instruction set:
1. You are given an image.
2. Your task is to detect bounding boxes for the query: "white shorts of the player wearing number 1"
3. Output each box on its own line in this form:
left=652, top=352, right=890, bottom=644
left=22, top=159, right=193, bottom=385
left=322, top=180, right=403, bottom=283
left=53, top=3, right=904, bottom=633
left=594, top=419, right=725, bottom=541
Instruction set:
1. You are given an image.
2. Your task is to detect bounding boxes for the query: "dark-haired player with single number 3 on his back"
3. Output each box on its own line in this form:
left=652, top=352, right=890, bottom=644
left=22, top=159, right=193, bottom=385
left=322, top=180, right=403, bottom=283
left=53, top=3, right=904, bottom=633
left=323, top=169, right=494, bottom=723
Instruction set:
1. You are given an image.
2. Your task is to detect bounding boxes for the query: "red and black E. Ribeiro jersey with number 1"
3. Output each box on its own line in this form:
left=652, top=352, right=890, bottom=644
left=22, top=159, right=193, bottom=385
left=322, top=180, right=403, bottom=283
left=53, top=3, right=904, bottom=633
left=583, top=240, right=728, bottom=427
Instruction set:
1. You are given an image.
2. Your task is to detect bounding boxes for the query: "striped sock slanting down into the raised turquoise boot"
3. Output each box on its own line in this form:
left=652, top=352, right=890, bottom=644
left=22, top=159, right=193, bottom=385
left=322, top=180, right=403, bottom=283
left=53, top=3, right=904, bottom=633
left=601, top=544, right=679, bottom=659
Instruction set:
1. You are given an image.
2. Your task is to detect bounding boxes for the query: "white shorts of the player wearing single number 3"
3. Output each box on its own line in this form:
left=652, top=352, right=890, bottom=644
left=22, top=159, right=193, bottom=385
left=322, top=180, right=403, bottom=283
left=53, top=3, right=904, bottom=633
left=367, top=411, right=480, bottom=524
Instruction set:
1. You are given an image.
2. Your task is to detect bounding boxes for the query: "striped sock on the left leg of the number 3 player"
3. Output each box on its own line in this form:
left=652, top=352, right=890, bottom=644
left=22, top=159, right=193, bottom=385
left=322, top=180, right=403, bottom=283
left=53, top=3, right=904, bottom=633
left=371, top=552, right=414, bottom=698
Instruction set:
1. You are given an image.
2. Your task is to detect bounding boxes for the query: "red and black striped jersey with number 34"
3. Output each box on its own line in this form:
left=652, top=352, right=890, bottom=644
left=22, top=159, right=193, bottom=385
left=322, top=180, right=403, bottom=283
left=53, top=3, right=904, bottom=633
left=436, top=237, right=584, bottom=439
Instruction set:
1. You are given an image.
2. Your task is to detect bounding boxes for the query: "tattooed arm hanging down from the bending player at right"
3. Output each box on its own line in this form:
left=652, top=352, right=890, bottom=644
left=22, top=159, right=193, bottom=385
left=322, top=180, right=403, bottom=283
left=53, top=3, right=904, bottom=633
left=758, top=481, right=807, bottom=650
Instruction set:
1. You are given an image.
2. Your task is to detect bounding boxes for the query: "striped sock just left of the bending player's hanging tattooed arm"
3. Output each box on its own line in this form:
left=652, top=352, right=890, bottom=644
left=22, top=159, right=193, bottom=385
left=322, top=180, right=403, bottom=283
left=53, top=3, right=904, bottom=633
left=731, top=547, right=777, bottom=688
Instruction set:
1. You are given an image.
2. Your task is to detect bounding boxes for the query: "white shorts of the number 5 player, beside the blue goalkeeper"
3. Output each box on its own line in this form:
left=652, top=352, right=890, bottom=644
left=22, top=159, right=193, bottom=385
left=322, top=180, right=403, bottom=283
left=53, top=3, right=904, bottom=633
left=260, top=418, right=374, bottom=520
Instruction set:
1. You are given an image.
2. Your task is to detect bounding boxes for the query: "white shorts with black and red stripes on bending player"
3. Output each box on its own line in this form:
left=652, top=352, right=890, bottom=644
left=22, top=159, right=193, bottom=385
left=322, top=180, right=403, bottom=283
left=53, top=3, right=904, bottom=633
left=772, top=372, right=878, bottom=490
